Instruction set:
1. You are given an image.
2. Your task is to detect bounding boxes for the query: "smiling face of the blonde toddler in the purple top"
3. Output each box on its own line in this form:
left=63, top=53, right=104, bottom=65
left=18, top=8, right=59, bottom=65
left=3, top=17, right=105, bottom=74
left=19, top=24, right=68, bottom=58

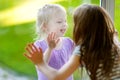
left=46, top=11, right=67, bottom=37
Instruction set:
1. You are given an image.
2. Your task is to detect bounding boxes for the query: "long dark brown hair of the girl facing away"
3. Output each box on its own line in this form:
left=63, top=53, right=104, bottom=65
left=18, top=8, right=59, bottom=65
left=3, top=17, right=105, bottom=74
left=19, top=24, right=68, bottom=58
left=73, top=4, right=118, bottom=80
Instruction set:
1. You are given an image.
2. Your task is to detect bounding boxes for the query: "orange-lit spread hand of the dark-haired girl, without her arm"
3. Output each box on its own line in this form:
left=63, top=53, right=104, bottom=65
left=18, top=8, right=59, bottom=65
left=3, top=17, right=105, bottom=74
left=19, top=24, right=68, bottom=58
left=24, top=43, right=44, bottom=65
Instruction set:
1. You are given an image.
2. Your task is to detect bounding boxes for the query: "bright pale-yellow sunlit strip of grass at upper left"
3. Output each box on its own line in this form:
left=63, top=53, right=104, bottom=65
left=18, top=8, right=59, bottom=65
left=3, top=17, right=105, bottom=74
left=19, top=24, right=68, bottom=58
left=0, top=0, right=64, bottom=26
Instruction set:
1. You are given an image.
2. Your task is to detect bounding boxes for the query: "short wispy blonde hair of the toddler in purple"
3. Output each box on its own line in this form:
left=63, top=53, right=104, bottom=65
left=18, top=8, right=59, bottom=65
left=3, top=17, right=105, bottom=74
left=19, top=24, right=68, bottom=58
left=36, top=4, right=66, bottom=39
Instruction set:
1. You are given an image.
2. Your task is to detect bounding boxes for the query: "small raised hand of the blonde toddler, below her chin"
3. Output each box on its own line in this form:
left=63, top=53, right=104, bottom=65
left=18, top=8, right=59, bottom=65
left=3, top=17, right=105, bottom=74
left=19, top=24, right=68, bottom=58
left=47, top=32, right=60, bottom=49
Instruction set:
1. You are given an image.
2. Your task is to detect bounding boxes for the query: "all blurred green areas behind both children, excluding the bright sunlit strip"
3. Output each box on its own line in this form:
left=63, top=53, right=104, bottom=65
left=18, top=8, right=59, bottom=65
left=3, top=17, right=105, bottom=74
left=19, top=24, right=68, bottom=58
left=0, top=0, right=120, bottom=80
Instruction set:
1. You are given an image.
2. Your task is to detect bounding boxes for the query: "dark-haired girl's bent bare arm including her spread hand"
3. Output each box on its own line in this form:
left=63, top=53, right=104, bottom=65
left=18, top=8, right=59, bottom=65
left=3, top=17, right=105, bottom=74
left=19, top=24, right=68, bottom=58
left=25, top=44, right=80, bottom=80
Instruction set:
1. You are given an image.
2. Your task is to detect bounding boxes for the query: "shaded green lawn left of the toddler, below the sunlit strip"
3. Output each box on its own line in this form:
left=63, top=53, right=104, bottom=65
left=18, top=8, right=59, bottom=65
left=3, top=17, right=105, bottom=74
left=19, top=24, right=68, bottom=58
left=0, top=23, right=36, bottom=76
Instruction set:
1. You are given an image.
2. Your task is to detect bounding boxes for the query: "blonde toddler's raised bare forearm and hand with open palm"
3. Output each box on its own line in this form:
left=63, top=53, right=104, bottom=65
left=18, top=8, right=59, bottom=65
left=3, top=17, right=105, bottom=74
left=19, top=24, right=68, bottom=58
left=43, top=32, right=59, bottom=63
